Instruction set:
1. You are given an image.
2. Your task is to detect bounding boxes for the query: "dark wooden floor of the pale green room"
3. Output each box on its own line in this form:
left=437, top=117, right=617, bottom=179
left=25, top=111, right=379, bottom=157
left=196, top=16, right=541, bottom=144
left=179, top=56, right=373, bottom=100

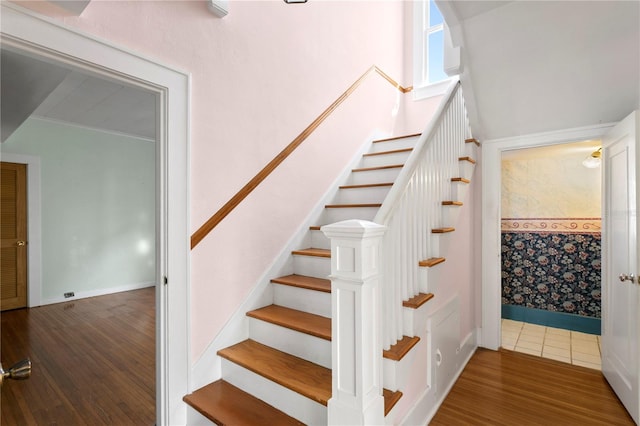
left=0, top=287, right=155, bottom=426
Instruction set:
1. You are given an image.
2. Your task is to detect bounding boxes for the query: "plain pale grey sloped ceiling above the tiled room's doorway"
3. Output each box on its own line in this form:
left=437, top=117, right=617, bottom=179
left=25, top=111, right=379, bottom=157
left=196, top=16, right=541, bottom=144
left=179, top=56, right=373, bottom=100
left=438, top=0, right=640, bottom=140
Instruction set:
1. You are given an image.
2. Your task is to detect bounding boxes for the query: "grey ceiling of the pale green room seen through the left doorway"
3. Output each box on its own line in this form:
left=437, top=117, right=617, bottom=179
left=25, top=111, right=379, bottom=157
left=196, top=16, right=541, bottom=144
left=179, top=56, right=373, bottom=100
left=0, top=49, right=156, bottom=142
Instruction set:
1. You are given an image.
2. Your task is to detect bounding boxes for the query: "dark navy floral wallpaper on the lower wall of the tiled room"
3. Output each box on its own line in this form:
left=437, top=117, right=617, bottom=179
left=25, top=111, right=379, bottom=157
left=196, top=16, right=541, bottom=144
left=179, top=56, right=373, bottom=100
left=502, top=221, right=601, bottom=318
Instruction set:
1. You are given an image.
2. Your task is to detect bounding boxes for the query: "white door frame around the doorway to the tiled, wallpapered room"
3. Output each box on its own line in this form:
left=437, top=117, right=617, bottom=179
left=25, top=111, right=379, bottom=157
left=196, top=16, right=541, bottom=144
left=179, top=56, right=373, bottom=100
left=478, top=123, right=615, bottom=350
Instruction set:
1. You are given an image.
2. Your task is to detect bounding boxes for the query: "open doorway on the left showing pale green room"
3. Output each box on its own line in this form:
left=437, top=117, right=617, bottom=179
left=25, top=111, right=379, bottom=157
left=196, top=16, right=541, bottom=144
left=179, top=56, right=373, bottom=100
left=0, top=46, right=161, bottom=424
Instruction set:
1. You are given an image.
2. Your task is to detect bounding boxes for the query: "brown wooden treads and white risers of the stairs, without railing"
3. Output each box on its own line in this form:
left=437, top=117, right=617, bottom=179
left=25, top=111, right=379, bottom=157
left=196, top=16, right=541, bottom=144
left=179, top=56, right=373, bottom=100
left=184, top=128, right=475, bottom=425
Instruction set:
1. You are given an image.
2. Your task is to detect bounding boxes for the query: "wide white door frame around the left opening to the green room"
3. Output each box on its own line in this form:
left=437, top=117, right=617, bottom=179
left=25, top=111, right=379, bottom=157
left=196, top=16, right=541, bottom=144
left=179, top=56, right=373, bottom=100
left=0, top=2, right=191, bottom=425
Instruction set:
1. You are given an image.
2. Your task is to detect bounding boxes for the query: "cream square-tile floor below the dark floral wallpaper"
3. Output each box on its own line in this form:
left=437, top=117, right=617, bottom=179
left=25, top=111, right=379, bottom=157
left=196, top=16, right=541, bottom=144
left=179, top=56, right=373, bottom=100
left=502, top=319, right=601, bottom=370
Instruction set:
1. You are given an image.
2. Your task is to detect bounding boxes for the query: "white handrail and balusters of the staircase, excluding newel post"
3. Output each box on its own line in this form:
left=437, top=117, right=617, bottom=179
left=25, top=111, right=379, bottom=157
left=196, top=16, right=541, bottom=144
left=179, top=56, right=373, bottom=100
left=373, top=80, right=471, bottom=350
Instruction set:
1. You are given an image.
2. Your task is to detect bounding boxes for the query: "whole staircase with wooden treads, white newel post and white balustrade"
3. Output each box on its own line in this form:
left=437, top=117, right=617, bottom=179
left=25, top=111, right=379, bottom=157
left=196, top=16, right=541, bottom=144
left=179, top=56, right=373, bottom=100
left=184, top=80, right=479, bottom=425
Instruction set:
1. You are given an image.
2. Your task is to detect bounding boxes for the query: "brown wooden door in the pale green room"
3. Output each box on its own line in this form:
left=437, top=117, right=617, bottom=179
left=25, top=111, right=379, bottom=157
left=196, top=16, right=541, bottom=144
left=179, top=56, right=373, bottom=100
left=0, top=162, right=27, bottom=311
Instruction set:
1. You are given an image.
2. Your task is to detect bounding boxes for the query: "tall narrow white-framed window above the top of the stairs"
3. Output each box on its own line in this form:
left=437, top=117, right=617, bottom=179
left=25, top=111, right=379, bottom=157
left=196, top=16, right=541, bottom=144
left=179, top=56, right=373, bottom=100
left=414, top=0, right=449, bottom=98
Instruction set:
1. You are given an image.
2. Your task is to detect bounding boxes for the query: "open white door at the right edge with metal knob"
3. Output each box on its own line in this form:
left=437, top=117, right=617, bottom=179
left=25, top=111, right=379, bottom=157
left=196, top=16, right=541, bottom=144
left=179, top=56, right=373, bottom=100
left=602, top=111, right=640, bottom=423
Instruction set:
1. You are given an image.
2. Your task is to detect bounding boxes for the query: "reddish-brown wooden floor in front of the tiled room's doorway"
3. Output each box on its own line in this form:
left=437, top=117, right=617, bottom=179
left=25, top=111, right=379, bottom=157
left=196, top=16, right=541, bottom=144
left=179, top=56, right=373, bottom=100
left=430, top=349, right=635, bottom=426
